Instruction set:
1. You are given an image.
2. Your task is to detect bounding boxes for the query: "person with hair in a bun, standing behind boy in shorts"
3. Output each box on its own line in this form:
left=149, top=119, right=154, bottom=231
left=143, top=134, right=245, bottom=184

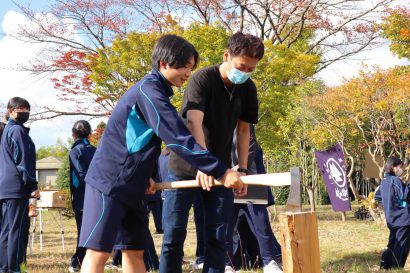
left=68, top=120, right=95, bottom=272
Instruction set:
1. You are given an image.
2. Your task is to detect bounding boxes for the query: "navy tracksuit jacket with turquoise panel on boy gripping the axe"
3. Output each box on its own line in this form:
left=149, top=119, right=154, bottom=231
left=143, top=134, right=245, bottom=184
left=85, top=70, right=227, bottom=208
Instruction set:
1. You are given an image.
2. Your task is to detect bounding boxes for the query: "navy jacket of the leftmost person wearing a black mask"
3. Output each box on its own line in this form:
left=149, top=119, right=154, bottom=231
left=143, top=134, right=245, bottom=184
left=0, top=118, right=37, bottom=199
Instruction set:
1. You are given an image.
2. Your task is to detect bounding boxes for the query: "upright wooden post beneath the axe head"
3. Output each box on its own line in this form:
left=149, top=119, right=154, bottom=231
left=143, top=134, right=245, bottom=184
left=279, top=211, right=321, bottom=273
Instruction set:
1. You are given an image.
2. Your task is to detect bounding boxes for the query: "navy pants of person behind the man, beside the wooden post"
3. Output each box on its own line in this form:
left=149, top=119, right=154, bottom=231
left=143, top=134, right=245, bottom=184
left=226, top=204, right=282, bottom=266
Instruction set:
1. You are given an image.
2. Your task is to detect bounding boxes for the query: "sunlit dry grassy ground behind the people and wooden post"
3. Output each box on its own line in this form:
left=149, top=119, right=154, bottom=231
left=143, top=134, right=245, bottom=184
left=27, top=206, right=410, bottom=273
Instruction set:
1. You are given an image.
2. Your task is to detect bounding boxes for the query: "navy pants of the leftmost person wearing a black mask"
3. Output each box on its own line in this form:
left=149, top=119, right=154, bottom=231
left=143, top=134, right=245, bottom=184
left=0, top=198, right=30, bottom=272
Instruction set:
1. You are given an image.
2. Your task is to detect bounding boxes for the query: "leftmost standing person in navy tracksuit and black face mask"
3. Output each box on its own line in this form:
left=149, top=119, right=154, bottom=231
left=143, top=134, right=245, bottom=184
left=0, top=97, right=40, bottom=272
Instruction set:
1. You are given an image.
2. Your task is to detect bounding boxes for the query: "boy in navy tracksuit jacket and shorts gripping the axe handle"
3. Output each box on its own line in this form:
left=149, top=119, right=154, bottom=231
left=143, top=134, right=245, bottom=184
left=80, top=35, right=243, bottom=273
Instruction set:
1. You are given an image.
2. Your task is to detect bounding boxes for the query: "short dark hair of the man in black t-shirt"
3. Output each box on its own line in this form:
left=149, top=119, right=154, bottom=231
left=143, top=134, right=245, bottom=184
left=228, top=31, right=265, bottom=60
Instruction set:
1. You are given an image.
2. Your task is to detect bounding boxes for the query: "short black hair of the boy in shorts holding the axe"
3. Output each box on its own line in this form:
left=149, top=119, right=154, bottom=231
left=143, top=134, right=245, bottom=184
left=151, top=34, right=199, bottom=69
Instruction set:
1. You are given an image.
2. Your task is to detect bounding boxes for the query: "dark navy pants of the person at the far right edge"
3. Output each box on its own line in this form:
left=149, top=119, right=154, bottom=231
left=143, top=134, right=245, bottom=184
left=380, top=223, right=410, bottom=269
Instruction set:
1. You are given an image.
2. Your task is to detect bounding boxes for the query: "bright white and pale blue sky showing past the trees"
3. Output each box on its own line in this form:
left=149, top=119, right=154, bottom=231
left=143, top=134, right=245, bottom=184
left=0, top=0, right=409, bottom=148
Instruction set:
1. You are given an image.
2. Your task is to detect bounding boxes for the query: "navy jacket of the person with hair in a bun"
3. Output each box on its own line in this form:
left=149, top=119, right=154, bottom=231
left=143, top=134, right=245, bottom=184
left=68, top=139, right=95, bottom=211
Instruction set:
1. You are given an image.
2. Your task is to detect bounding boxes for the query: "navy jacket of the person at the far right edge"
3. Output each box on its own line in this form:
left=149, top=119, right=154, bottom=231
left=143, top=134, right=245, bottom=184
left=375, top=173, right=410, bottom=228
